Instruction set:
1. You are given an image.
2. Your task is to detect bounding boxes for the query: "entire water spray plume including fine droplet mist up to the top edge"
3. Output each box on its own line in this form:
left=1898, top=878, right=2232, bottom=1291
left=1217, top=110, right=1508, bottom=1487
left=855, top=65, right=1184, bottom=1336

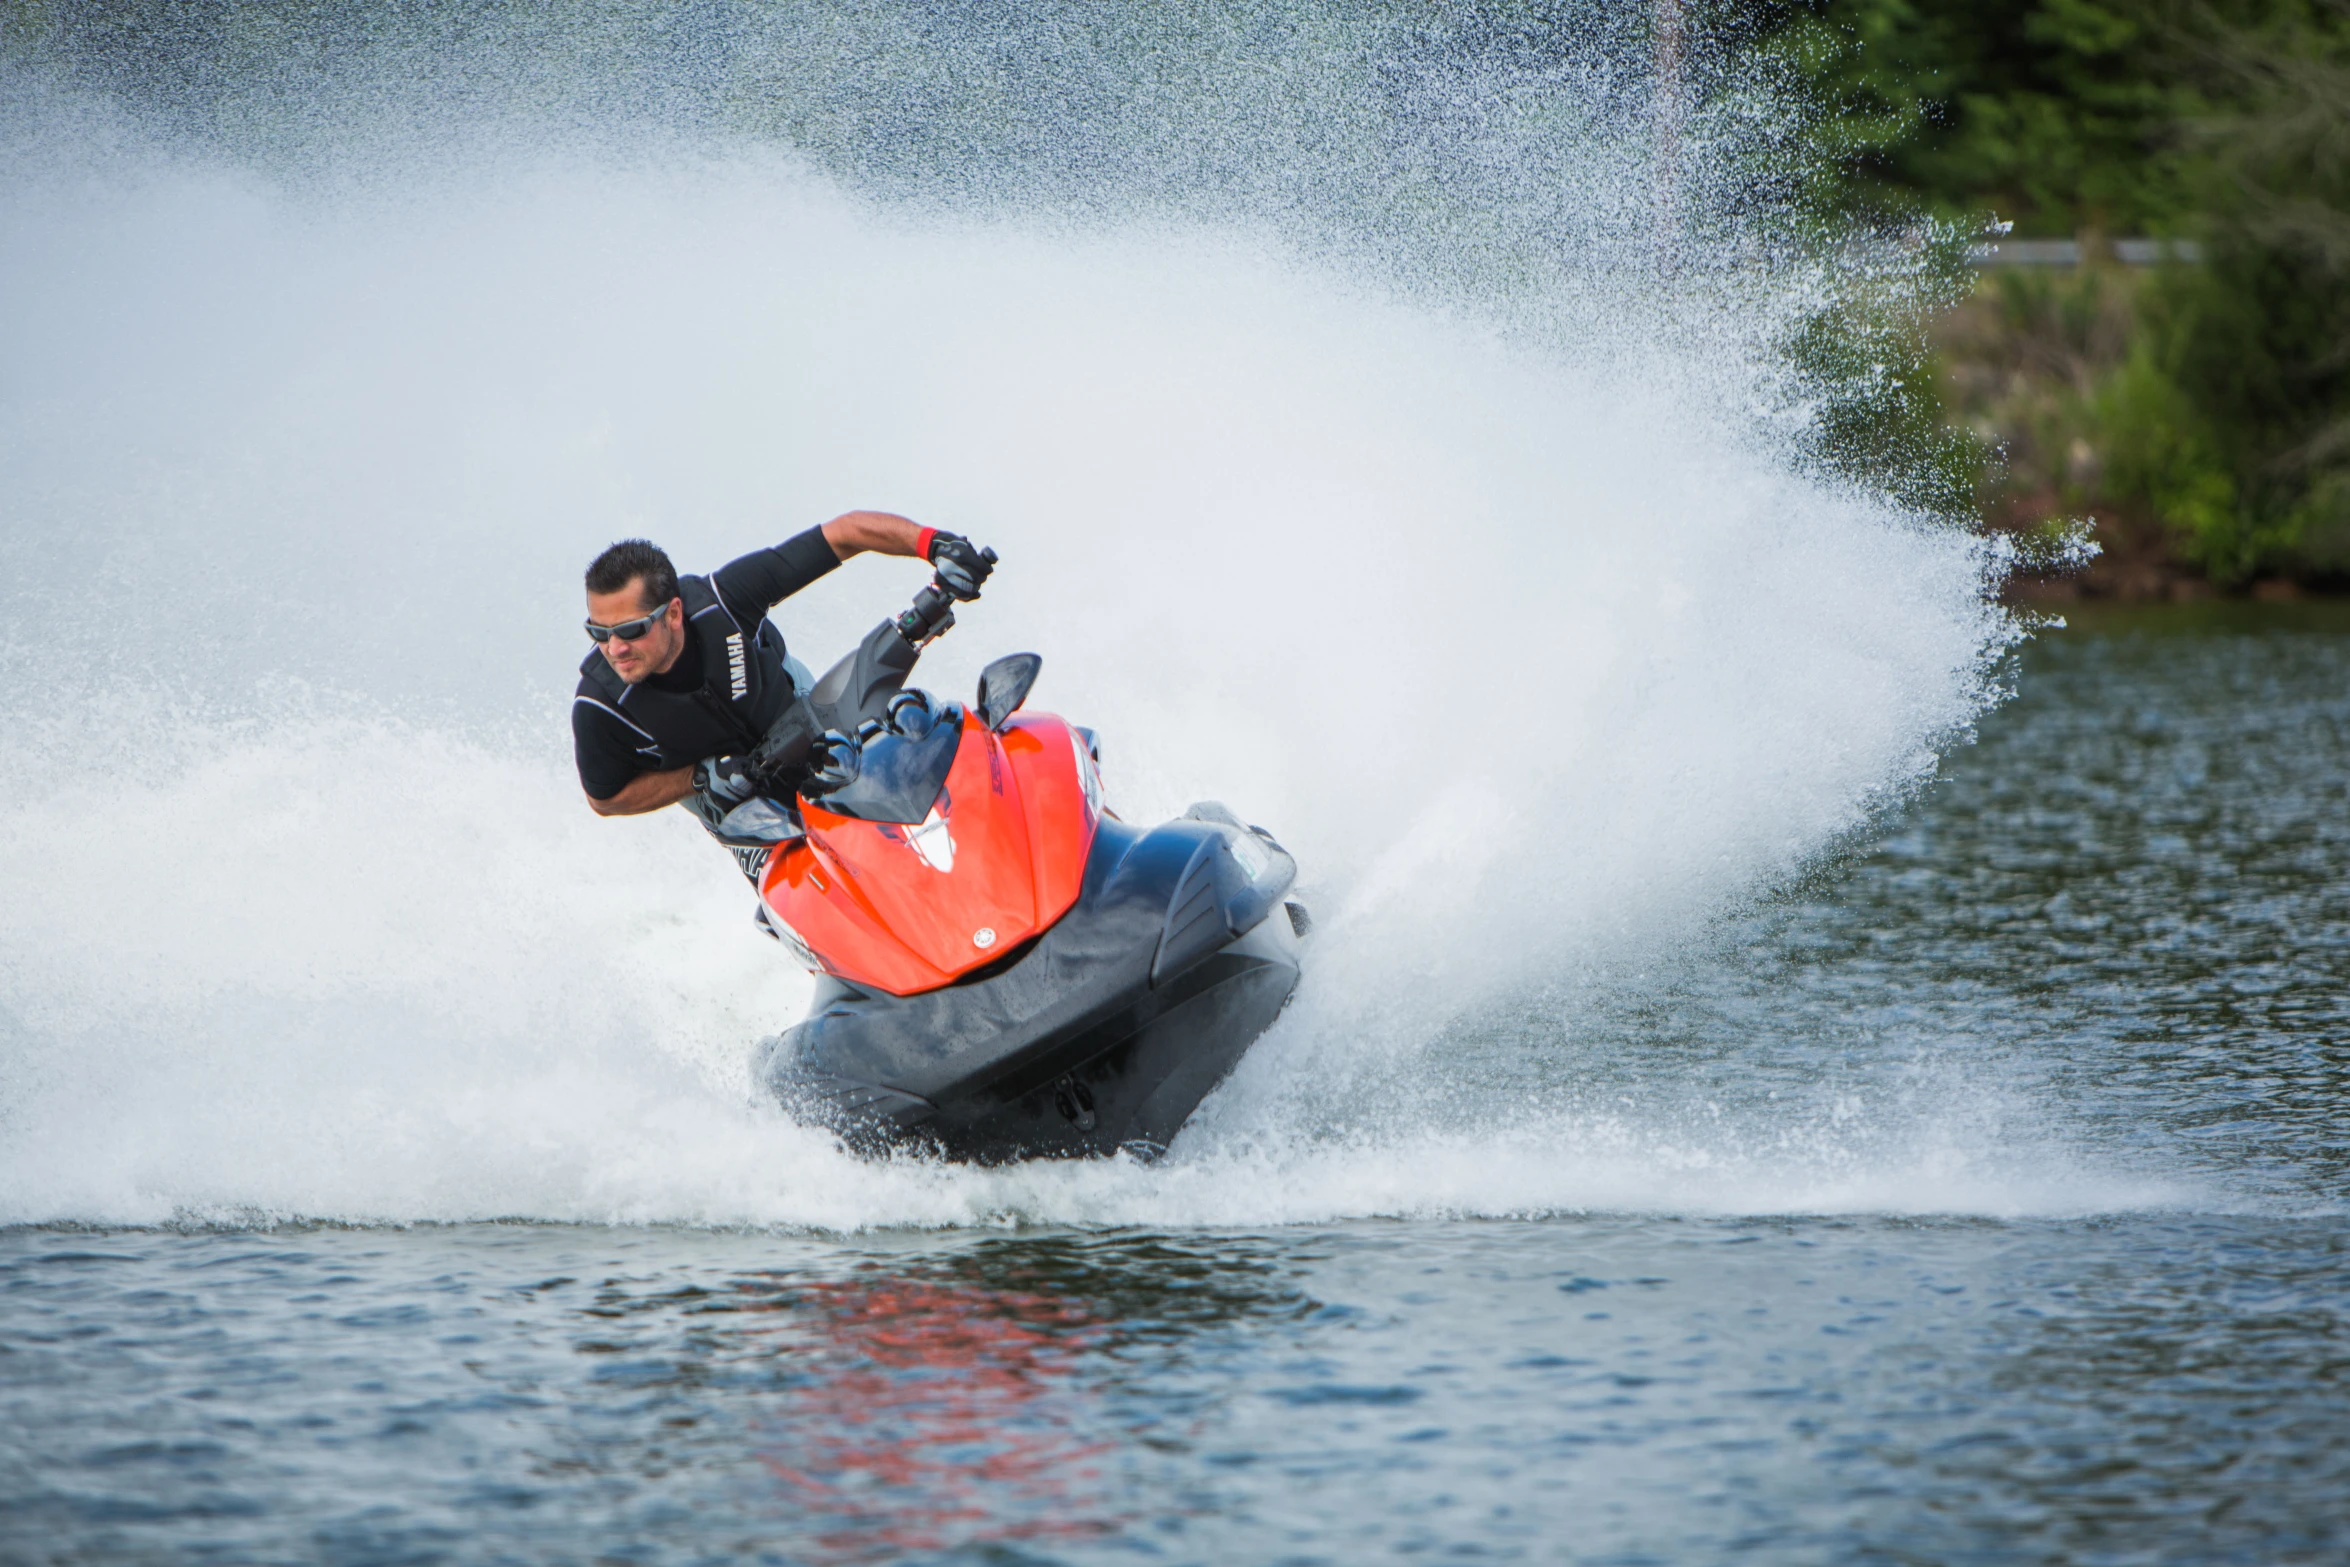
left=0, top=5, right=2035, bottom=1226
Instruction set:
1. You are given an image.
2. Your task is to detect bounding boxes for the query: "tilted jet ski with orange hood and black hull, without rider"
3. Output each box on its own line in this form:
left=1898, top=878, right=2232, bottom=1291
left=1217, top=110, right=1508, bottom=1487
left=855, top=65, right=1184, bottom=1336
left=705, top=563, right=1309, bottom=1163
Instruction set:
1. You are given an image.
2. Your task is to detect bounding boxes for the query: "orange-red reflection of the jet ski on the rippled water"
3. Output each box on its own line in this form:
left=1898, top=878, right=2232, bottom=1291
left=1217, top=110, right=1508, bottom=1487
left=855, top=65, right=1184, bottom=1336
left=745, top=1278, right=1116, bottom=1558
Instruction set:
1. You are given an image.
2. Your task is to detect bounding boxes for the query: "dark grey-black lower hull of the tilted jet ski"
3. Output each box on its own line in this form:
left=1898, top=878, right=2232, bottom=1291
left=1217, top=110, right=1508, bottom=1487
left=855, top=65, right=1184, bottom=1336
left=761, top=806, right=1304, bottom=1163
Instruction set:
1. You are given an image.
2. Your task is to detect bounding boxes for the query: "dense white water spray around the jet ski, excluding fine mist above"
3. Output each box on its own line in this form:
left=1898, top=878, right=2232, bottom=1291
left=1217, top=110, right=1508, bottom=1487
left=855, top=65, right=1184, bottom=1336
left=0, top=18, right=2120, bottom=1226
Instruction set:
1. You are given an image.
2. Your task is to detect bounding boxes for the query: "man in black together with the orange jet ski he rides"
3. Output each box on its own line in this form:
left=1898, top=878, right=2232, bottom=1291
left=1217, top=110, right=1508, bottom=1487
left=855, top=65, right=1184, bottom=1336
left=573, top=512, right=1307, bottom=1161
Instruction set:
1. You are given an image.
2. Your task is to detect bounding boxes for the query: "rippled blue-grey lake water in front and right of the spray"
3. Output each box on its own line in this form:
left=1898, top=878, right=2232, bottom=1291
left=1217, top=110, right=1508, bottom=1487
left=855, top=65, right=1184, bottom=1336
left=0, top=608, right=2350, bottom=1562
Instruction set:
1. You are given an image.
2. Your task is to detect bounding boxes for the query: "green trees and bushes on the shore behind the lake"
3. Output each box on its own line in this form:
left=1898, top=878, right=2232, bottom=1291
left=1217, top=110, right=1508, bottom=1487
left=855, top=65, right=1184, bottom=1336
left=1758, top=0, right=2350, bottom=601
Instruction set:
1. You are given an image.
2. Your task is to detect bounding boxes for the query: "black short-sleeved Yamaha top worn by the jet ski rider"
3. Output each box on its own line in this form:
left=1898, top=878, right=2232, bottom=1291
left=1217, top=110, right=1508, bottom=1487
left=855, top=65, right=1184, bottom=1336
left=571, top=529, right=841, bottom=799
